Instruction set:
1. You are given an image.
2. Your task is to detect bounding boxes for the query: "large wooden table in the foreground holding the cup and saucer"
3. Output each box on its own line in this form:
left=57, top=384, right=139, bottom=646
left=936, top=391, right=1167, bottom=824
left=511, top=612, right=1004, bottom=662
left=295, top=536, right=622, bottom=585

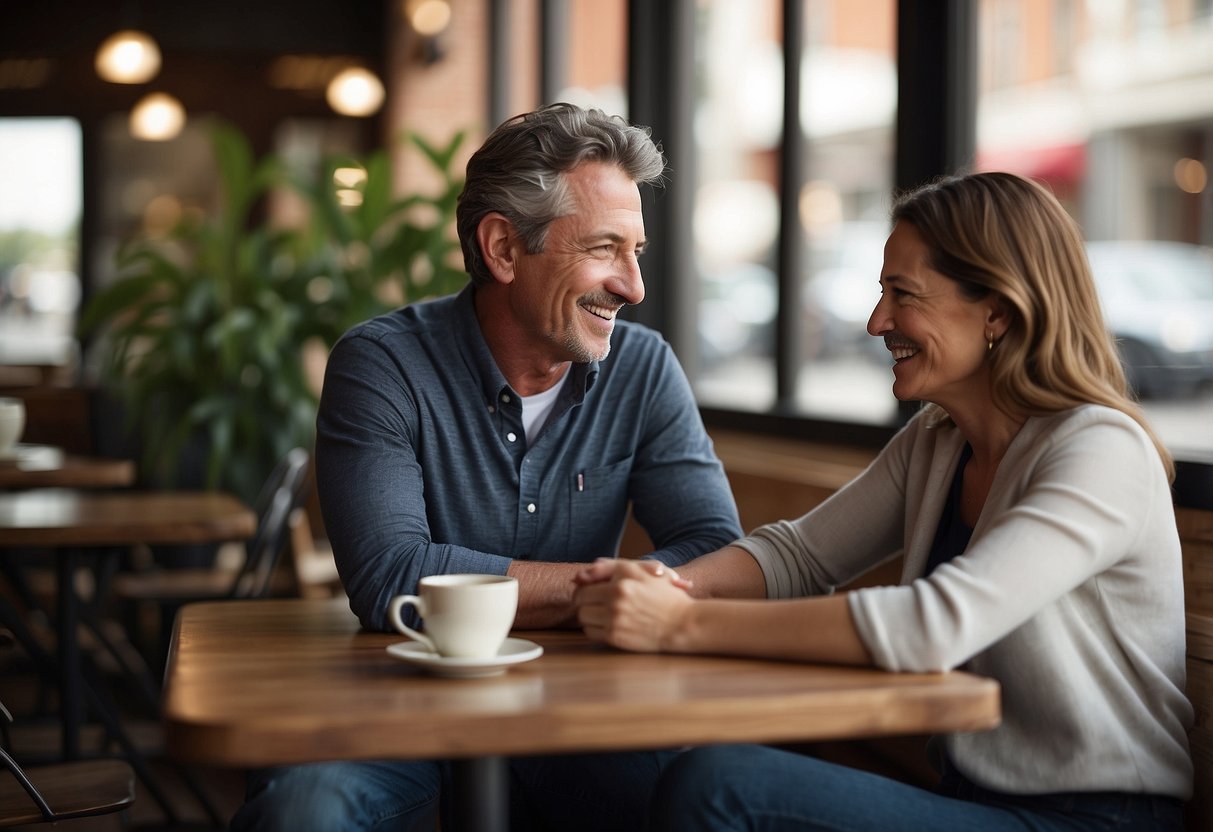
left=164, top=599, right=1000, bottom=828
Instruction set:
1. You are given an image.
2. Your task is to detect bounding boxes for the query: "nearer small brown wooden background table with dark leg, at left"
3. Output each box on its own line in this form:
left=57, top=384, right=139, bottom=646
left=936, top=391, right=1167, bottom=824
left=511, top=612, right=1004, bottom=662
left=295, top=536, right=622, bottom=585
left=0, top=489, right=257, bottom=759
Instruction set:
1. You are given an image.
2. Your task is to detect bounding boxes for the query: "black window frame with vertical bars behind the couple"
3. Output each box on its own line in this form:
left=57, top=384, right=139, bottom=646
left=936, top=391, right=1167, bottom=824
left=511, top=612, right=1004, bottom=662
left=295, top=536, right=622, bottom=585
left=504, top=0, right=1213, bottom=509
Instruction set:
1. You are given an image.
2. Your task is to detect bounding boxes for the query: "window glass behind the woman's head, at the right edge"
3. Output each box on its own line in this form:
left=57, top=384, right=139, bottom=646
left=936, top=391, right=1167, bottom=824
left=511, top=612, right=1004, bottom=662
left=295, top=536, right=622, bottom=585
left=978, top=0, right=1213, bottom=461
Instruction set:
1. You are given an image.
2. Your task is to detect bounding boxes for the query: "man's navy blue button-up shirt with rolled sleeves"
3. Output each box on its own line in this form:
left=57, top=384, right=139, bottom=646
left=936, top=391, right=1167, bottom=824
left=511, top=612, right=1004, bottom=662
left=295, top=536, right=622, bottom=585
left=315, top=286, right=741, bottom=629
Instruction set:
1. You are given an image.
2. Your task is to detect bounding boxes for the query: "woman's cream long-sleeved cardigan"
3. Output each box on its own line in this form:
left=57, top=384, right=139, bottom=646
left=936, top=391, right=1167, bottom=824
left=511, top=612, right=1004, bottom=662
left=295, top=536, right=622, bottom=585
left=738, top=405, right=1192, bottom=799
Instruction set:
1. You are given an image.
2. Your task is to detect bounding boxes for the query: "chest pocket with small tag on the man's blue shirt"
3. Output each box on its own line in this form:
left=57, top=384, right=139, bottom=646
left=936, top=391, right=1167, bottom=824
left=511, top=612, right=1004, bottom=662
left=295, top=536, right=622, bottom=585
left=568, top=456, right=632, bottom=560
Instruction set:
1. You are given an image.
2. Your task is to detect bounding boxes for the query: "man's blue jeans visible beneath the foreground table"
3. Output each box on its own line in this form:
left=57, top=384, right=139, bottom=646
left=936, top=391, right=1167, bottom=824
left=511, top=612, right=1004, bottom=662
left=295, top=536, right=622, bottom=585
left=230, top=751, right=678, bottom=832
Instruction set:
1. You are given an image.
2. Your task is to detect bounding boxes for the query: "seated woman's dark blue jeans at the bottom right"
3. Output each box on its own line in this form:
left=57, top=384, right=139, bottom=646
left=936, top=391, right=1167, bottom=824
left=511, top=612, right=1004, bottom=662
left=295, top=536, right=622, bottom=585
left=649, top=746, right=1183, bottom=832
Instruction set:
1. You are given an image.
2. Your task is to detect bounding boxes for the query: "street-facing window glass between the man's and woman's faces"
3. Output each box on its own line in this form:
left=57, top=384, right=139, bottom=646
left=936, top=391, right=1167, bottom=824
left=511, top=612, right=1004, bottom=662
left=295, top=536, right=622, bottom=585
left=694, top=0, right=898, bottom=423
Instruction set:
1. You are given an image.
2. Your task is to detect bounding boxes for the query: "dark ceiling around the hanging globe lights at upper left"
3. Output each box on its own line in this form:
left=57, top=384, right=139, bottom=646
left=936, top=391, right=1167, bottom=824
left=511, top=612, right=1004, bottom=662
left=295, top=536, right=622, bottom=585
left=0, top=0, right=388, bottom=137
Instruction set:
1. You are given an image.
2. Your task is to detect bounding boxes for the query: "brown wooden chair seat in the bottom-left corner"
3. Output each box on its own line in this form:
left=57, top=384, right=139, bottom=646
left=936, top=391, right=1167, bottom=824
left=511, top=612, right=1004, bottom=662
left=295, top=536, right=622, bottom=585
left=0, top=759, right=135, bottom=826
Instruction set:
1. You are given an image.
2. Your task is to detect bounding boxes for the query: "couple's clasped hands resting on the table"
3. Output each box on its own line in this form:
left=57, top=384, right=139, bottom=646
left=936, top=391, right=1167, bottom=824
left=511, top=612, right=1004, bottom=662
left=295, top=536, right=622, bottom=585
left=573, top=558, right=694, bottom=653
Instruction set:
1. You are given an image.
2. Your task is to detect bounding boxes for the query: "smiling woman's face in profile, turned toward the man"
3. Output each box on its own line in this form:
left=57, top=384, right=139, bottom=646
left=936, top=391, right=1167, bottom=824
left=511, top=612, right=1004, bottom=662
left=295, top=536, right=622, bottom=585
left=867, top=222, right=1003, bottom=411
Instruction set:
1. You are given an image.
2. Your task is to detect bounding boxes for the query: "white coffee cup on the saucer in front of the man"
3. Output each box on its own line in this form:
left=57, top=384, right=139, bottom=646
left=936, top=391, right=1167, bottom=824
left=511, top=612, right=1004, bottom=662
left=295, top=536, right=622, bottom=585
left=387, top=575, right=518, bottom=659
